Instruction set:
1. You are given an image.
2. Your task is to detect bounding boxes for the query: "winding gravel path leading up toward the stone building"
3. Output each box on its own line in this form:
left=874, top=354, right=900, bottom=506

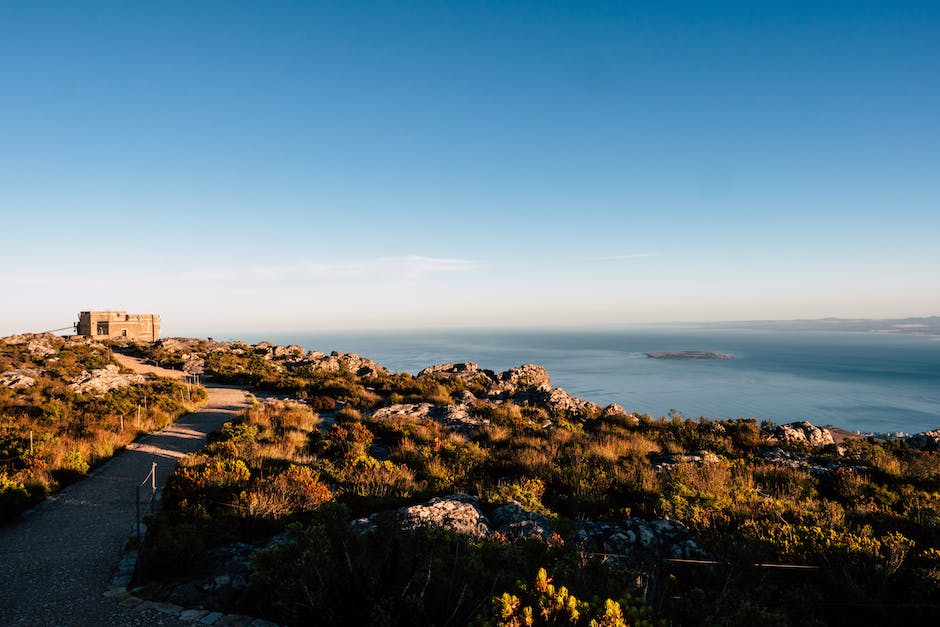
left=0, top=355, right=248, bottom=627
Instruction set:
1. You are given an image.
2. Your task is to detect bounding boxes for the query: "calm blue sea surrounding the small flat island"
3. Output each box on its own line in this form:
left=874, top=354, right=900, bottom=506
left=222, top=328, right=940, bottom=433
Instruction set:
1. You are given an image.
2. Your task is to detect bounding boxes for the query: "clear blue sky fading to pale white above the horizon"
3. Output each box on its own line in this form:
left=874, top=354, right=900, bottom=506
left=0, top=0, right=940, bottom=335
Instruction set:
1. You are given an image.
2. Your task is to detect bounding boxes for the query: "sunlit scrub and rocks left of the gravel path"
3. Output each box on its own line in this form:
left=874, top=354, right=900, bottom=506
left=0, top=335, right=206, bottom=520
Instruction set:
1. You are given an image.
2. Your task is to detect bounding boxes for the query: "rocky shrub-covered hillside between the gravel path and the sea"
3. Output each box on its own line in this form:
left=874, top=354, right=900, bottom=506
left=114, top=339, right=940, bottom=625
